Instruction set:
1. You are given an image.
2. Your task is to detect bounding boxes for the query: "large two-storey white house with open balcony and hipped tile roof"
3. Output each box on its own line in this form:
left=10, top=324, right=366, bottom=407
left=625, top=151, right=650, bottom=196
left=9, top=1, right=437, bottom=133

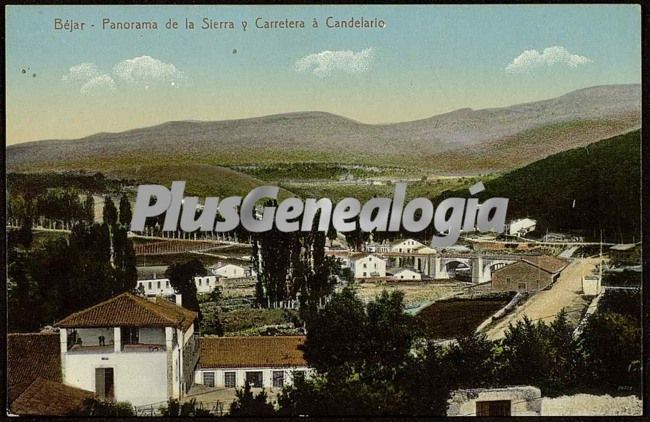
left=56, top=293, right=199, bottom=406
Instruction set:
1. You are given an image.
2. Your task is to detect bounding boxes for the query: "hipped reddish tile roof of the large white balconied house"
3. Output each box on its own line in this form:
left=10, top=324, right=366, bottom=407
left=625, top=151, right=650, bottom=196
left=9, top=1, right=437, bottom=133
left=55, top=293, right=197, bottom=330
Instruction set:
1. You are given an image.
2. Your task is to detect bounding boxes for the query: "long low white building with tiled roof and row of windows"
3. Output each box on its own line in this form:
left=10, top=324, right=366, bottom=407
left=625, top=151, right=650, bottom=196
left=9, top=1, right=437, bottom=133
left=194, top=336, right=309, bottom=389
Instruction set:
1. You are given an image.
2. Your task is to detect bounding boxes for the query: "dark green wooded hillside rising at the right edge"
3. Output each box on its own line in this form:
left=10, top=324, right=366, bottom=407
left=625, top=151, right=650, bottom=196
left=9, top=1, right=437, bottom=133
left=442, top=130, right=641, bottom=242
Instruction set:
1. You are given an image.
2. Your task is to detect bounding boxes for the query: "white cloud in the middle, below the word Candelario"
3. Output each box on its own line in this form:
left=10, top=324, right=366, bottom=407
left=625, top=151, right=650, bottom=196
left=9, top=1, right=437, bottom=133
left=295, top=48, right=375, bottom=78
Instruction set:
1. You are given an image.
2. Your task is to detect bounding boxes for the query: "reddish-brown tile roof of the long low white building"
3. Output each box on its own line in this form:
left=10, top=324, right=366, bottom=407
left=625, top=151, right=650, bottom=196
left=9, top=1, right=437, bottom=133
left=199, top=336, right=307, bottom=368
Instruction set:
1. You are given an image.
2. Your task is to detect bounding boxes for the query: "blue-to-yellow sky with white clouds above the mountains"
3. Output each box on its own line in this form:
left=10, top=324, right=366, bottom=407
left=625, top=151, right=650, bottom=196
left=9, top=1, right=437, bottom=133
left=5, top=5, right=641, bottom=144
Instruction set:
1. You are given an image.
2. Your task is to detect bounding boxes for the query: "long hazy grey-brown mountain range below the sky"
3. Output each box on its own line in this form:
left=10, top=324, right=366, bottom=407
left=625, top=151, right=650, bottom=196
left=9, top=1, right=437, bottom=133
left=6, top=84, right=641, bottom=196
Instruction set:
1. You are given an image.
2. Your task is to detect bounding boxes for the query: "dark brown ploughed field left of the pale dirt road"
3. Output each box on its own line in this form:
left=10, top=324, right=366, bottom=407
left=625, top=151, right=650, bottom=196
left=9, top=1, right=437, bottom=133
left=417, top=296, right=509, bottom=340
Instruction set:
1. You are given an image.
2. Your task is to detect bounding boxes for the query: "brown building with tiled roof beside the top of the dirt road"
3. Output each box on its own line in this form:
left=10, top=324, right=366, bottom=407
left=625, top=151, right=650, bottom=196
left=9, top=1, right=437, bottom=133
left=492, top=255, right=568, bottom=292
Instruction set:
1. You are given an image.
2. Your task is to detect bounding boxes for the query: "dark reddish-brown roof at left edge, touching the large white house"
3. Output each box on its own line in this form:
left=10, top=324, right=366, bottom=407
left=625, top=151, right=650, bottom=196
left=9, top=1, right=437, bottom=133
left=7, top=333, right=62, bottom=403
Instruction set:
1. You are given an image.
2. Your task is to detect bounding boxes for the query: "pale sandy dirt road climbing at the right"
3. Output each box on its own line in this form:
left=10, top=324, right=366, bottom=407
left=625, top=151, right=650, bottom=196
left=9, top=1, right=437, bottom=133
left=486, top=258, right=599, bottom=340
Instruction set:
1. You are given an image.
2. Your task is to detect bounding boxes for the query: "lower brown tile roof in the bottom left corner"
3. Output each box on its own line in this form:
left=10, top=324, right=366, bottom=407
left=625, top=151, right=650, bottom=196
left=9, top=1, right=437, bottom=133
left=10, top=378, right=94, bottom=416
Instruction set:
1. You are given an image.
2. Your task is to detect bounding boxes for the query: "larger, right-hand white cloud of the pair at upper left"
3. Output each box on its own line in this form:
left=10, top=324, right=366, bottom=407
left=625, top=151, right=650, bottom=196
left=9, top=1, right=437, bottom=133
left=113, top=56, right=184, bottom=84
